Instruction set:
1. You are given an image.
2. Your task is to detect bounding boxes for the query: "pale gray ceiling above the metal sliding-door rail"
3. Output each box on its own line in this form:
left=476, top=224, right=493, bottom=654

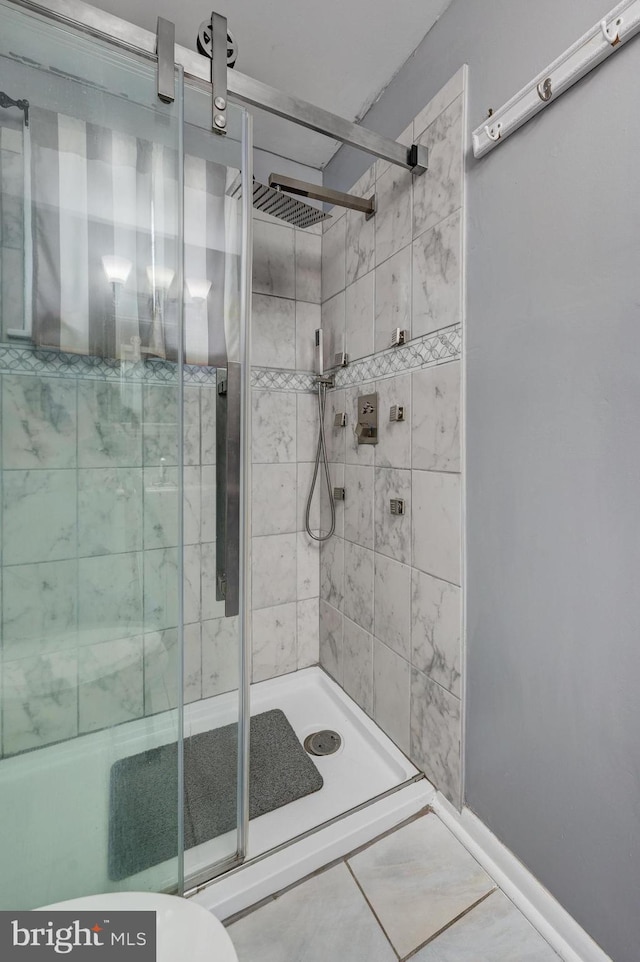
left=93, top=0, right=451, bottom=168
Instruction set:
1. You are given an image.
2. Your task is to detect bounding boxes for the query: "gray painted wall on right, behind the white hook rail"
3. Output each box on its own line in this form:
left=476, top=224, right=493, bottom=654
left=325, top=0, right=640, bottom=962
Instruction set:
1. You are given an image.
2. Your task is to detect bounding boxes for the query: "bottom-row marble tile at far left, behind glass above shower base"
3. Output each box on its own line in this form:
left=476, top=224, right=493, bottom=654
left=2, top=651, right=78, bottom=755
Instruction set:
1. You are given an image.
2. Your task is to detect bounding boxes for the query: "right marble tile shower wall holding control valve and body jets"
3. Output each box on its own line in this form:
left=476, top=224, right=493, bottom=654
left=320, top=69, right=465, bottom=804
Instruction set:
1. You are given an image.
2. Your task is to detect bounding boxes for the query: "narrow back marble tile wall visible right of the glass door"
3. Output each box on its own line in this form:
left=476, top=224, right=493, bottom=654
left=251, top=211, right=322, bottom=682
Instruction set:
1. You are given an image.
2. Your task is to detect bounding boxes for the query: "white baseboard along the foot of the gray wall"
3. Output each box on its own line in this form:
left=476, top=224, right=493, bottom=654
left=431, top=792, right=612, bottom=962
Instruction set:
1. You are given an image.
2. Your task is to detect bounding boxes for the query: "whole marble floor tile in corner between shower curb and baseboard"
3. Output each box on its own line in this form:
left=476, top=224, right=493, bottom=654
left=349, top=814, right=492, bottom=959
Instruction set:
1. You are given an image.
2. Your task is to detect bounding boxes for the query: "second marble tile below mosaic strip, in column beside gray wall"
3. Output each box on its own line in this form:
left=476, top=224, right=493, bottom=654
left=411, top=471, right=461, bottom=585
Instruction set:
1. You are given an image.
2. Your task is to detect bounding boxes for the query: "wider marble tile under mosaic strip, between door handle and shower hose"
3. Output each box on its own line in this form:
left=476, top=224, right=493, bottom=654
left=251, top=391, right=296, bottom=464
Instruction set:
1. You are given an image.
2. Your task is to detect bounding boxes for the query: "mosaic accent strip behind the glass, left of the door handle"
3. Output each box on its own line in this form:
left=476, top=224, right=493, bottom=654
left=0, top=344, right=216, bottom=385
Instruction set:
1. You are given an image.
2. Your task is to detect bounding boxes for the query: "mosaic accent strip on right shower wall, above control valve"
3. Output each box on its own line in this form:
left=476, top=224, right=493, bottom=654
left=336, top=324, right=462, bottom=387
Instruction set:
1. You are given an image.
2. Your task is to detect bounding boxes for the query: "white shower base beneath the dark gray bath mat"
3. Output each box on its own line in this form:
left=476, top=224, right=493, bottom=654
left=0, top=668, right=424, bottom=911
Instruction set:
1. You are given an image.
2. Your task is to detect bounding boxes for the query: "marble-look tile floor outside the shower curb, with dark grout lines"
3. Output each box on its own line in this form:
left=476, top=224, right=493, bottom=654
left=229, top=814, right=559, bottom=962
